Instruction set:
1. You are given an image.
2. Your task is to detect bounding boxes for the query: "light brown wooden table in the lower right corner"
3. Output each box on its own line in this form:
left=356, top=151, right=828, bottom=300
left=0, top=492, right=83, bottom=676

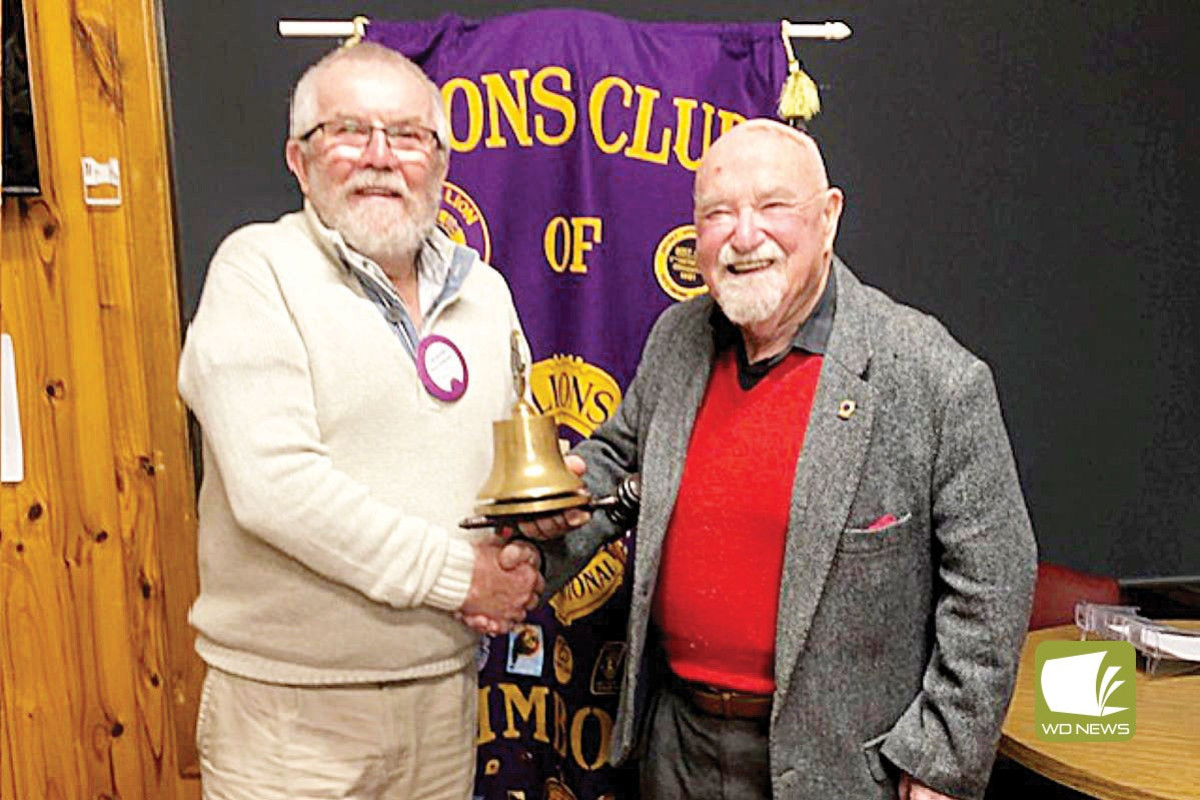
left=1000, top=621, right=1200, bottom=800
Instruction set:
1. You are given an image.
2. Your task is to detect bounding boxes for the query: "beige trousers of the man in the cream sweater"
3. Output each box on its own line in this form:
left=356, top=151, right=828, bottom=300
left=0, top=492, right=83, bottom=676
left=196, top=667, right=476, bottom=800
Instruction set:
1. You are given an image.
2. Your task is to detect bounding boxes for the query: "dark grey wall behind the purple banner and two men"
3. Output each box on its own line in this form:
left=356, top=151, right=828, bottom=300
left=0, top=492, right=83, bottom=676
left=163, top=0, right=1200, bottom=577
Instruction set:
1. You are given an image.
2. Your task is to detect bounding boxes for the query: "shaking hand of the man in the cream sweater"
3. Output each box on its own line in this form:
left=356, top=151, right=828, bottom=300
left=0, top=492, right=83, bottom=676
left=460, top=536, right=546, bottom=636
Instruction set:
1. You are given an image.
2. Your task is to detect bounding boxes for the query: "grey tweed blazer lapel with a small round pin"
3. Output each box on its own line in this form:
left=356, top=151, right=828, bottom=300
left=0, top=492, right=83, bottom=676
left=772, top=258, right=875, bottom=718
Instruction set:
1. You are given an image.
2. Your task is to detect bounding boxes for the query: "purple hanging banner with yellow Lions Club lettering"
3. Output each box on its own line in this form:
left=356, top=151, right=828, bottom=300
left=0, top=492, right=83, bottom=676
left=367, top=10, right=787, bottom=800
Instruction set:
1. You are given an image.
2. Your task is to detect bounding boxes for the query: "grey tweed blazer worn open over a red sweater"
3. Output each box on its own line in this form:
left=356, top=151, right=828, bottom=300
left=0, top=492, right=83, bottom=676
left=544, top=259, right=1036, bottom=799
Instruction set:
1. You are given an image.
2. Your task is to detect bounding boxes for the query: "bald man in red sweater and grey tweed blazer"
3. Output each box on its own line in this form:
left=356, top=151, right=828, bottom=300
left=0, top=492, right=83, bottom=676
left=523, top=120, right=1036, bottom=800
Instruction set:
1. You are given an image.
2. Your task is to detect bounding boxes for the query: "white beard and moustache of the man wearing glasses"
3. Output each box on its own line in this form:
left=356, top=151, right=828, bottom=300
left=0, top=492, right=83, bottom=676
left=310, top=169, right=440, bottom=261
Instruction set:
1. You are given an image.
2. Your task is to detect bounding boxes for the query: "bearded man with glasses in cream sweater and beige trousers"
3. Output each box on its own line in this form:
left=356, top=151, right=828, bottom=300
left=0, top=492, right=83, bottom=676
left=179, top=44, right=542, bottom=800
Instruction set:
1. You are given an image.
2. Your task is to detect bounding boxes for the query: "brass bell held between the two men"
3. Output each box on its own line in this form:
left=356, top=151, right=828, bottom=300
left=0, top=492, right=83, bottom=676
left=475, top=331, right=592, bottom=521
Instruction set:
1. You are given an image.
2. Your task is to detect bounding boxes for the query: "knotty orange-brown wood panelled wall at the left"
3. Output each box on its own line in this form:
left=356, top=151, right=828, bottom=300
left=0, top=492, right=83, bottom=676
left=0, top=0, right=202, bottom=800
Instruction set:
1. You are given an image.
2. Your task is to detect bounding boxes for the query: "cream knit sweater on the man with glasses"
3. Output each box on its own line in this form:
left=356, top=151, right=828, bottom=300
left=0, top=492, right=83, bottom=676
left=179, top=212, right=518, bottom=684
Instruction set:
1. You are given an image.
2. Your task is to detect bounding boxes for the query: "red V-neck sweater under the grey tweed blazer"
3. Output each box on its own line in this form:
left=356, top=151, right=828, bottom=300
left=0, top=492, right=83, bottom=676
left=653, top=348, right=821, bottom=694
